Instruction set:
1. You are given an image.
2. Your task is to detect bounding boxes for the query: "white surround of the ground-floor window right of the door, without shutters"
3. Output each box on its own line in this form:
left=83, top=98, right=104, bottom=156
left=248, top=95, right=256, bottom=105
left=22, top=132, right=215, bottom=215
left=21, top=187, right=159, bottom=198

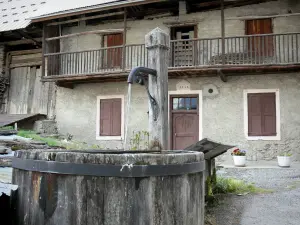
left=244, top=89, right=281, bottom=141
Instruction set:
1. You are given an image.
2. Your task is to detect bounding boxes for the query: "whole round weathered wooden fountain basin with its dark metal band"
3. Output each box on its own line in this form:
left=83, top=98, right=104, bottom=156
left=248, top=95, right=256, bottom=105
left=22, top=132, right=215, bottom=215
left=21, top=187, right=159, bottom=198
left=13, top=150, right=204, bottom=225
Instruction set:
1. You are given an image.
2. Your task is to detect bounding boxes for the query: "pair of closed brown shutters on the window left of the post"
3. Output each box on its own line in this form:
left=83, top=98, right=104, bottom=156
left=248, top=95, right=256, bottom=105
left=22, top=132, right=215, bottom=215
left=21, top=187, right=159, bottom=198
left=99, top=98, right=122, bottom=136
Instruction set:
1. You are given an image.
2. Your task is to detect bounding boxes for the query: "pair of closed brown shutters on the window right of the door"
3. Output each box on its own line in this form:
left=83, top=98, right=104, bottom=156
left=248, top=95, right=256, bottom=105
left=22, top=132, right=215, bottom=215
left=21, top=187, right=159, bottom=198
left=247, top=93, right=277, bottom=136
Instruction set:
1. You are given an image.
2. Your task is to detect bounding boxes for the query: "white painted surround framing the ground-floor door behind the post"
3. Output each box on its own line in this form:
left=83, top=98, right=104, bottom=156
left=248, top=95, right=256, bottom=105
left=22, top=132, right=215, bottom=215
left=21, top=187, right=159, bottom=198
left=168, top=90, right=203, bottom=149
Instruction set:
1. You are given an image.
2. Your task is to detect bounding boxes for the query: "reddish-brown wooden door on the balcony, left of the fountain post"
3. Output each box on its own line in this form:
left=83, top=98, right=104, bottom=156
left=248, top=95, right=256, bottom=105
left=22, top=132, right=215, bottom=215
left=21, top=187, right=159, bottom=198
left=107, top=33, right=123, bottom=68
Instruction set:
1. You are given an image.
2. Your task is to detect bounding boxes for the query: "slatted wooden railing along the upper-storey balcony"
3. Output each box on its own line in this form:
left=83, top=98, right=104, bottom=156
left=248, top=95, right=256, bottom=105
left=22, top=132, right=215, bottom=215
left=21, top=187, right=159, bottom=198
left=45, top=33, right=300, bottom=76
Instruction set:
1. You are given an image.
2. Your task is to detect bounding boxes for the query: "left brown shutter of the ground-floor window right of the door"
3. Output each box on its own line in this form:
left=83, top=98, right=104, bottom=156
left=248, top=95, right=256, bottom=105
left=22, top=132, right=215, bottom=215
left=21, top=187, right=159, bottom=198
left=248, top=94, right=262, bottom=136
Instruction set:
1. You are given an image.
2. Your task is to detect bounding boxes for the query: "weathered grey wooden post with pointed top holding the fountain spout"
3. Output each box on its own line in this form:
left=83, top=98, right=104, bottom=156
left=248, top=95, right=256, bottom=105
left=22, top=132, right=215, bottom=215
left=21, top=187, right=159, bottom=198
left=145, top=28, right=170, bottom=150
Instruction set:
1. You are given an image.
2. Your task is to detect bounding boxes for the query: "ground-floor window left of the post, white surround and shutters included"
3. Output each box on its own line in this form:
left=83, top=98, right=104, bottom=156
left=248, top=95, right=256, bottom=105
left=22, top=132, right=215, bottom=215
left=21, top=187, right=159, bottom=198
left=96, top=96, right=124, bottom=140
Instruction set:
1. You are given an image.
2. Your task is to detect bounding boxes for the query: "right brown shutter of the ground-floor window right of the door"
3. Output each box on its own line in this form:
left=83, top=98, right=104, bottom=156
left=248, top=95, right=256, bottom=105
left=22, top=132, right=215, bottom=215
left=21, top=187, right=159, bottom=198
left=261, top=93, right=276, bottom=136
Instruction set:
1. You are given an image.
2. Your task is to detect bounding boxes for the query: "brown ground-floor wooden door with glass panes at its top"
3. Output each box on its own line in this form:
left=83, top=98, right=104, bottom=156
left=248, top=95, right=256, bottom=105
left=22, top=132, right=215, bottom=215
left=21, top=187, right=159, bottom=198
left=170, top=96, right=199, bottom=150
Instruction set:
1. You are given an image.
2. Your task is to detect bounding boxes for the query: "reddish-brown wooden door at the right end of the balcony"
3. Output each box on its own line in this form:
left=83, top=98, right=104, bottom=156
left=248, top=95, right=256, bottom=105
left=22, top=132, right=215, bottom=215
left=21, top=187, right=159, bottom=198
left=246, top=19, right=274, bottom=57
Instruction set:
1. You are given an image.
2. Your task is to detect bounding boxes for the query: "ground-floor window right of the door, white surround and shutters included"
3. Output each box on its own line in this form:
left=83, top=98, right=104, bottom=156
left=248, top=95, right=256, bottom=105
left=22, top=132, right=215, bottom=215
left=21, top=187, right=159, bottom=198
left=244, top=89, right=280, bottom=140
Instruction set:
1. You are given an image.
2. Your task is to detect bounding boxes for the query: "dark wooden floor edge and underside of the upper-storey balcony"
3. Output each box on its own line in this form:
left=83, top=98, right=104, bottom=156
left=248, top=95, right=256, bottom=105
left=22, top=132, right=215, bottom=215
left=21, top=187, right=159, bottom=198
left=42, top=64, right=300, bottom=88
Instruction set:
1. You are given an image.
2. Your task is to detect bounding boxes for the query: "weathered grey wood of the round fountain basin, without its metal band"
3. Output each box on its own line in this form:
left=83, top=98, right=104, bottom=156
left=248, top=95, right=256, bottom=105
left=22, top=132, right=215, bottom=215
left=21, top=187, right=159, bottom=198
left=13, top=150, right=204, bottom=225
